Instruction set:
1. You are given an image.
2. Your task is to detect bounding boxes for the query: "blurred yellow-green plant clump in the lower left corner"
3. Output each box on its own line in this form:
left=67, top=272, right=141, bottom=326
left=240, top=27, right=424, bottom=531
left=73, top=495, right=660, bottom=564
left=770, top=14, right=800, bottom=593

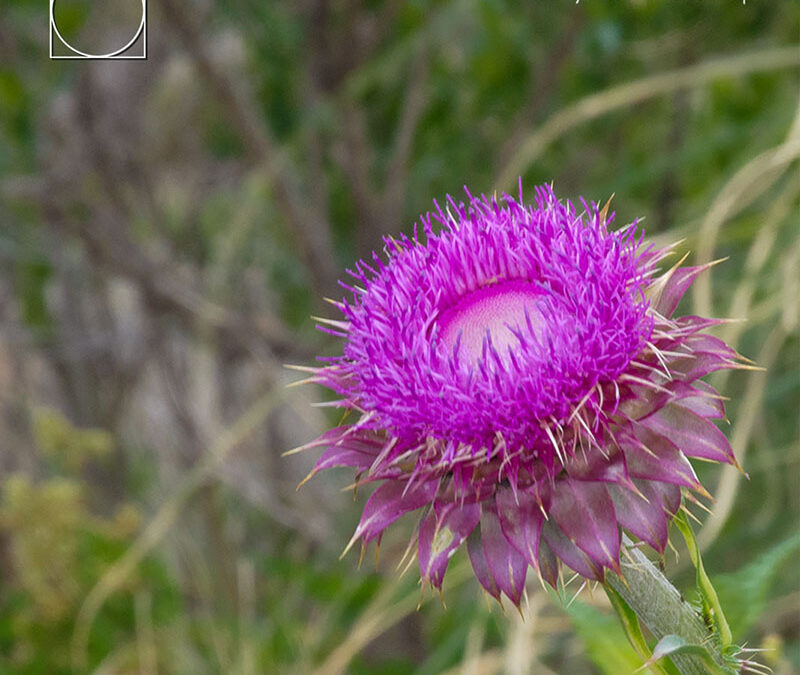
left=0, top=409, right=161, bottom=673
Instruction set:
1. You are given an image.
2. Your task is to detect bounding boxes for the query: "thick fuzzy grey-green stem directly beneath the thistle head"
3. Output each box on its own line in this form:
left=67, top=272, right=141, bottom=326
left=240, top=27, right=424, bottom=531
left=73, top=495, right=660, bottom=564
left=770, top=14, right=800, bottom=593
left=606, top=536, right=724, bottom=675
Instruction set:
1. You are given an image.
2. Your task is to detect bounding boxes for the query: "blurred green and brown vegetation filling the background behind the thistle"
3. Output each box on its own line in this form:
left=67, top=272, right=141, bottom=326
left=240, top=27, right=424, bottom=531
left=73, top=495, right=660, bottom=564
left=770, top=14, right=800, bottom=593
left=0, top=0, right=800, bottom=675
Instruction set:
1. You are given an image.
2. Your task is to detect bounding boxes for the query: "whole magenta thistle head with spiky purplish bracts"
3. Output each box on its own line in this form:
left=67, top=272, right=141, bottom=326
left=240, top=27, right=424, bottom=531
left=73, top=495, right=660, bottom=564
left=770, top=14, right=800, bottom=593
left=294, top=186, right=739, bottom=605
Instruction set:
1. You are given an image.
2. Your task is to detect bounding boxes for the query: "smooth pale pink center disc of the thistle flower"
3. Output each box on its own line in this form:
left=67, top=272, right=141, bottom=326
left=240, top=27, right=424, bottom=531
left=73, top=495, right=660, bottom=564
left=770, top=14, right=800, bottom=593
left=437, top=281, right=542, bottom=363
